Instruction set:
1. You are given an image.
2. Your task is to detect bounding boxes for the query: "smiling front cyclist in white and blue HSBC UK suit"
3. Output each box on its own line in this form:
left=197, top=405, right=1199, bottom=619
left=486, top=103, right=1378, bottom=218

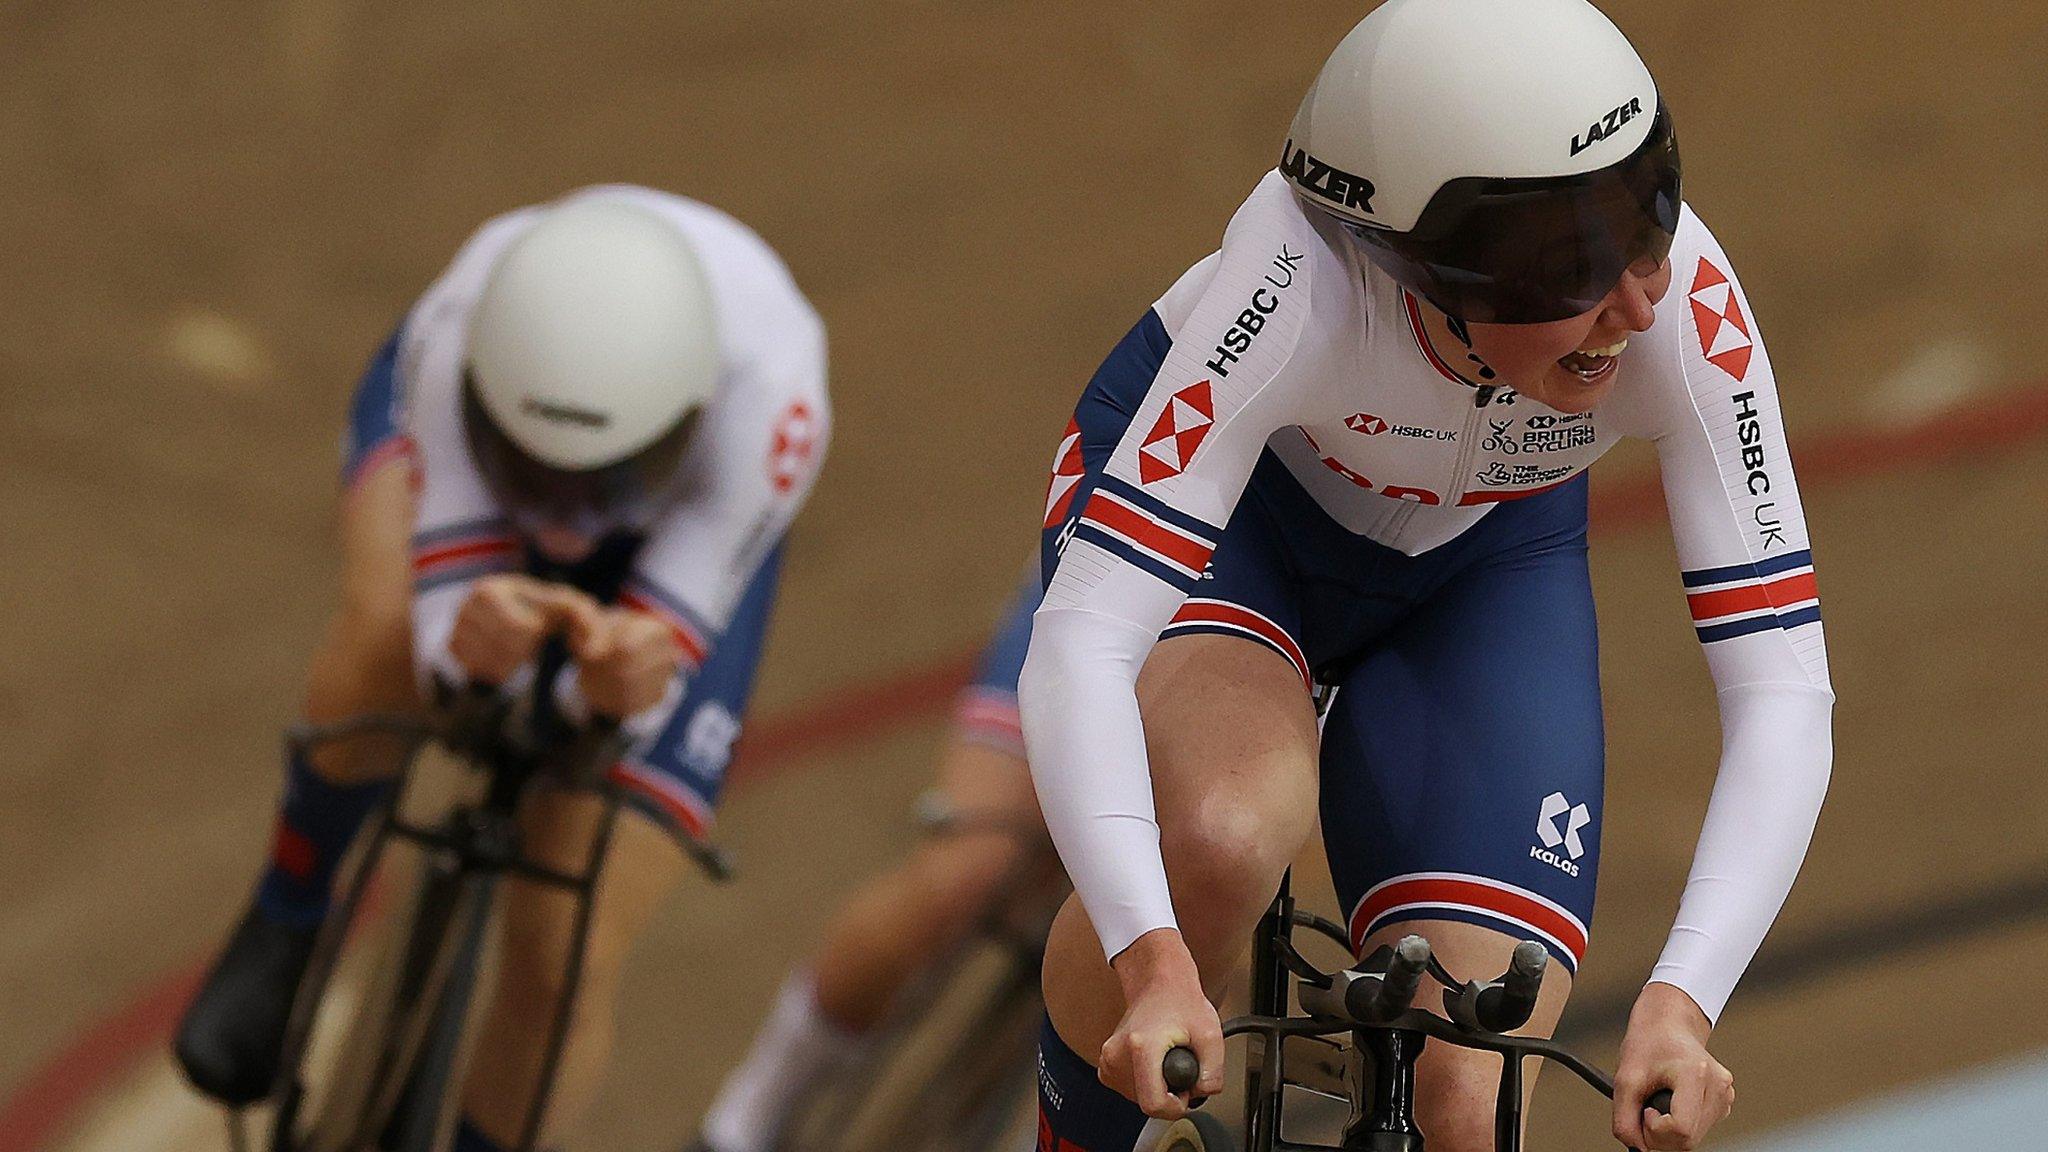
left=1020, top=0, right=1833, bottom=1152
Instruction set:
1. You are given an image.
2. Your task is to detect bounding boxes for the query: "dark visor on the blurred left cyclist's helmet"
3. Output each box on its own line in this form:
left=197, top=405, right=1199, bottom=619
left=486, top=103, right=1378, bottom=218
left=463, top=365, right=696, bottom=519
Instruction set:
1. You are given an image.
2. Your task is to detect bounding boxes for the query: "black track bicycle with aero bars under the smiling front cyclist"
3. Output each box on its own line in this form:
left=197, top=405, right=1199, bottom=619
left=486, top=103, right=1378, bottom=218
left=1153, top=877, right=1671, bottom=1152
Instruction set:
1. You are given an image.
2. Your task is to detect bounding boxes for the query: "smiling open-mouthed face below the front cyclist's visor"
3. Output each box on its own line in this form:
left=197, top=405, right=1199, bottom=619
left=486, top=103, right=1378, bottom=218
left=1466, top=260, right=1671, bottom=412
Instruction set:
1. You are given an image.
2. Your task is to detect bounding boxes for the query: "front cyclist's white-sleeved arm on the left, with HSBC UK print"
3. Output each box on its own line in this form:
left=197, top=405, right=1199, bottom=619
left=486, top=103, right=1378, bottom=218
left=1018, top=175, right=1313, bottom=957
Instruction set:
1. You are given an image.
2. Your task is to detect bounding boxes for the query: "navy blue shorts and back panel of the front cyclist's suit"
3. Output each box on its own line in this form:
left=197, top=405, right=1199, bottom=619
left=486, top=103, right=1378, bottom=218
left=1044, top=314, right=1606, bottom=965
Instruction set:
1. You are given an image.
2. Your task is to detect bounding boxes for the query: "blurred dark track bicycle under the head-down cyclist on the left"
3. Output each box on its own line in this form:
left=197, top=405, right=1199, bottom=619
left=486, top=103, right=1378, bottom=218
left=229, top=655, right=733, bottom=1152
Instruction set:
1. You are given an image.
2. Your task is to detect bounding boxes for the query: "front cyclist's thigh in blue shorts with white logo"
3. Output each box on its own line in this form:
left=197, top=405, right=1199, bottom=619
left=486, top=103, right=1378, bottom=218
left=1323, top=520, right=1604, bottom=976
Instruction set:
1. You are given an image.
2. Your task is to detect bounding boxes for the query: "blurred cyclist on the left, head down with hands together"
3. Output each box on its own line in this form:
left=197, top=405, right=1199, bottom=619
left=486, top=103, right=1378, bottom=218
left=176, top=184, right=827, bottom=1152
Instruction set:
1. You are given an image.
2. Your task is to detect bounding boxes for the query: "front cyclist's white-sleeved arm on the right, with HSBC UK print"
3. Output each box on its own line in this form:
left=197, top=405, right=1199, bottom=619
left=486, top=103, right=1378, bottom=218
left=1651, top=219, right=1835, bottom=1021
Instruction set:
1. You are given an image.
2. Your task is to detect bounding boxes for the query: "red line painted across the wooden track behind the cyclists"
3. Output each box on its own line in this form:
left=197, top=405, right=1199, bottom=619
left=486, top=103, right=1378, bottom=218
left=0, top=383, right=2048, bottom=1152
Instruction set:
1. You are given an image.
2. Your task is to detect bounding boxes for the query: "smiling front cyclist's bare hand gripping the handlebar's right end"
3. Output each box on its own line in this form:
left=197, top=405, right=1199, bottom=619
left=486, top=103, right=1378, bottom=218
left=1614, top=984, right=1735, bottom=1152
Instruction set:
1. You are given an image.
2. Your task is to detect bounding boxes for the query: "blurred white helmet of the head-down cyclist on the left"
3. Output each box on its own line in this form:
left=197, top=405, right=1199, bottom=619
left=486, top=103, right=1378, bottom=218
left=463, top=195, right=719, bottom=510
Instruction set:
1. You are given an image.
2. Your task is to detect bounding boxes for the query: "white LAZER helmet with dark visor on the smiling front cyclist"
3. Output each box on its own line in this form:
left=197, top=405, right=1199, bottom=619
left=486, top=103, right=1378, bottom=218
left=1280, top=0, right=1679, bottom=324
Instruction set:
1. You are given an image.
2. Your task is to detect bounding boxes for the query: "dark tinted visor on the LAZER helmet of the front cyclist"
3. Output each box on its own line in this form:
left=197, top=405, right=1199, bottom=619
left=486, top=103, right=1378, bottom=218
left=1346, top=107, right=1679, bottom=324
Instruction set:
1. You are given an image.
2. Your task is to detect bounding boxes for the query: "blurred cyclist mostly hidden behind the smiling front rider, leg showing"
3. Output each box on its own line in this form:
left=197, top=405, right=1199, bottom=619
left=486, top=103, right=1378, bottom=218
left=696, top=564, right=1038, bottom=1152
